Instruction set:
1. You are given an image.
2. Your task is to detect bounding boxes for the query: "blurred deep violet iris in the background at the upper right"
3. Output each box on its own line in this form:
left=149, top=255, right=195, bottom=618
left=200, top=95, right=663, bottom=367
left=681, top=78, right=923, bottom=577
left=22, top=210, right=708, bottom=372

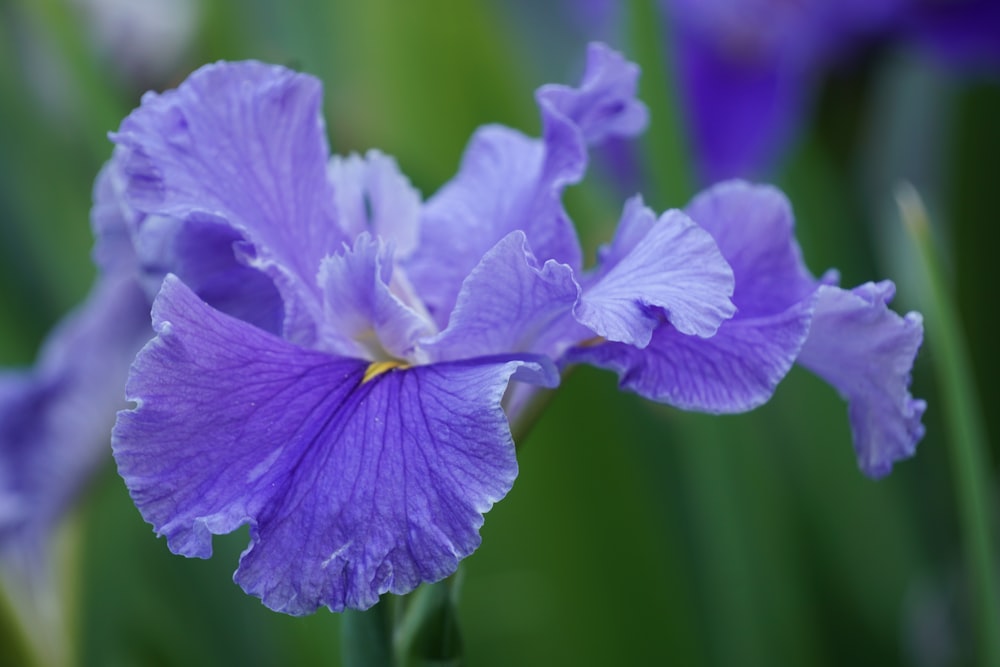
left=661, top=0, right=1000, bottom=183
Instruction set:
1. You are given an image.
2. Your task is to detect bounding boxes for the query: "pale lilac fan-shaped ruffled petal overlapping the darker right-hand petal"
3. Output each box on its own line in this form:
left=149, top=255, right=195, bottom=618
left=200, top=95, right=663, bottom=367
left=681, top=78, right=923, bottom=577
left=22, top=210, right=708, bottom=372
left=575, top=197, right=736, bottom=348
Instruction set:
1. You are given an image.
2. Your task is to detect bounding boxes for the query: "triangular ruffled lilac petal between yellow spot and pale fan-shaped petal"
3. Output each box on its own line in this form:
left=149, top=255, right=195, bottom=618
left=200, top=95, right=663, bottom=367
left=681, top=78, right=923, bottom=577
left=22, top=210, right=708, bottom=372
left=423, top=231, right=587, bottom=360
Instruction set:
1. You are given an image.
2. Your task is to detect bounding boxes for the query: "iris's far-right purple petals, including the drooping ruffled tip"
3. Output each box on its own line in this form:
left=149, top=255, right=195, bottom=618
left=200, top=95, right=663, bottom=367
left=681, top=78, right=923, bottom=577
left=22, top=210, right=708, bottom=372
left=566, top=181, right=926, bottom=477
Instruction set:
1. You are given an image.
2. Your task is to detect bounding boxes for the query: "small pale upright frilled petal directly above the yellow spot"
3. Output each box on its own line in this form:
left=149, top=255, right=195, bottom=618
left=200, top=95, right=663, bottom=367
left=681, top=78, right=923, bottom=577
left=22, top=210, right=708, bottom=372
left=318, top=232, right=435, bottom=361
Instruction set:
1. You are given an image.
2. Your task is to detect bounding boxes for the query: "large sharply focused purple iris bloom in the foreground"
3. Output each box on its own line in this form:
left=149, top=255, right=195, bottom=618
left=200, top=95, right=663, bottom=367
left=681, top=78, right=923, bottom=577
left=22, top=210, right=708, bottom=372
left=0, top=40, right=924, bottom=614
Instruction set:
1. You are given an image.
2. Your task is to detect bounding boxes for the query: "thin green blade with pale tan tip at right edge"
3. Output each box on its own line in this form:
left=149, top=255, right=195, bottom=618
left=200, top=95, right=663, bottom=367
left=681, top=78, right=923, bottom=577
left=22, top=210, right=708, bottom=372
left=896, top=183, right=1000, bottom=667
